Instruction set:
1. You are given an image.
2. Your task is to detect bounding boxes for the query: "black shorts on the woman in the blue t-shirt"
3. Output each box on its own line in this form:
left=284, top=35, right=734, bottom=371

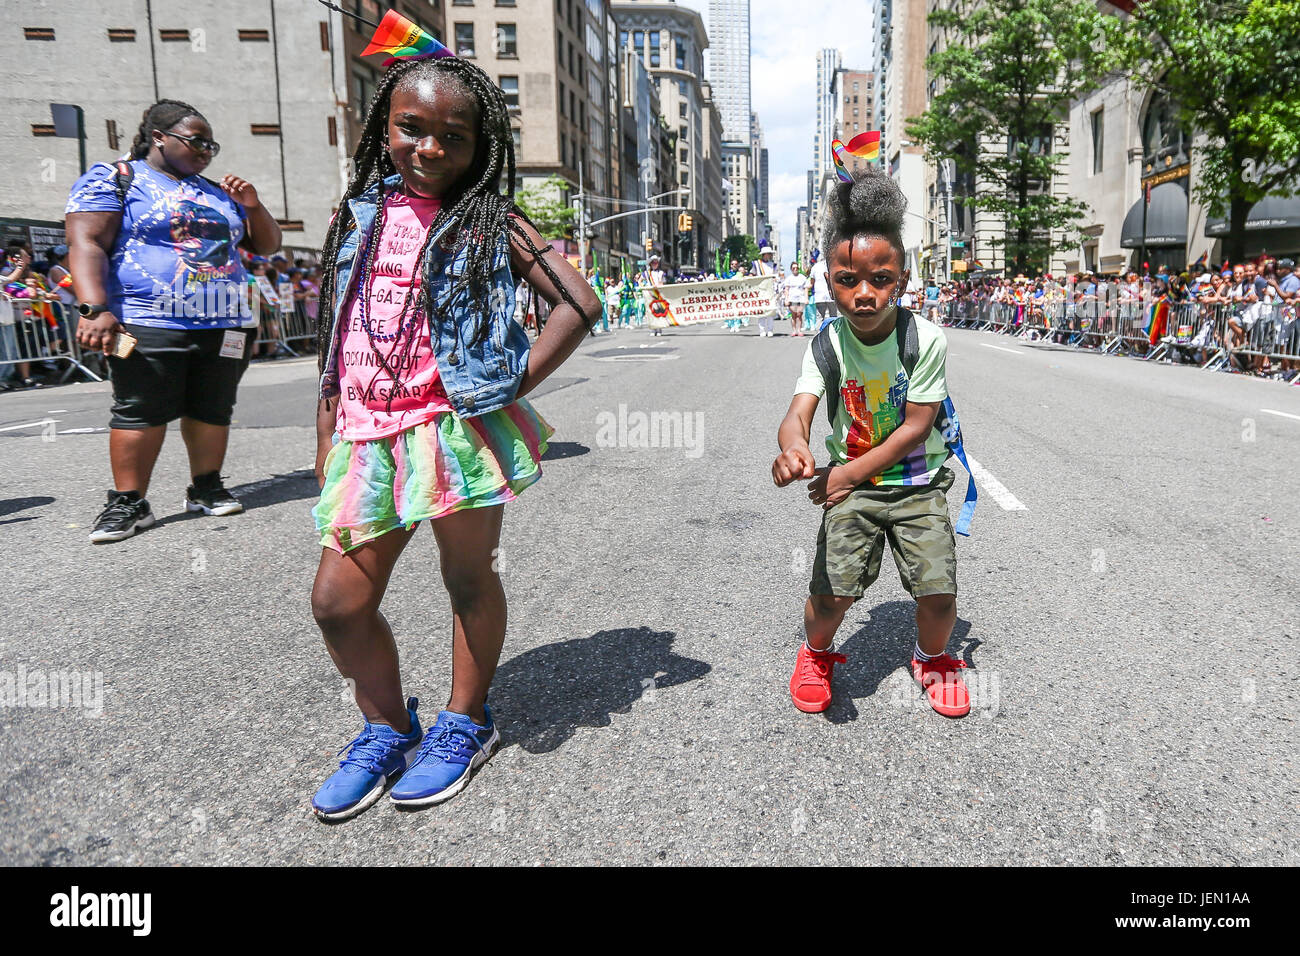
left=108, top=324, right=257, bottom=428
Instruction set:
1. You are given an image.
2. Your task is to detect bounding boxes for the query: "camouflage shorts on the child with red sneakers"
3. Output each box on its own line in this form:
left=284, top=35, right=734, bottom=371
left=809, top=468, right=957, bottom=598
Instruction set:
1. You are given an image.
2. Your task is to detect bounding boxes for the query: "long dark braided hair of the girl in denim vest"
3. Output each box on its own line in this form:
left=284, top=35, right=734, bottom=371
left=316, top=57, right=595, bottom=372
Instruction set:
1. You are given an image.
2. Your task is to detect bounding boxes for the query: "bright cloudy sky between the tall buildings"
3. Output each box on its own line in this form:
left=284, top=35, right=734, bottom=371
left=677, top=0, right=872, bottom=263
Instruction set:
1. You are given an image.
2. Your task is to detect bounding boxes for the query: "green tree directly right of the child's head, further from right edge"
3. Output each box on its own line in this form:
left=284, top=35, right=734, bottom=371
left=906, top=0, right=1118, bottom=272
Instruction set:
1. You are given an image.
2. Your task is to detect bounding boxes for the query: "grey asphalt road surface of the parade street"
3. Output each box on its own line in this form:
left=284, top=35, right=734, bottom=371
left=0, top=326, right=1300, bottom=865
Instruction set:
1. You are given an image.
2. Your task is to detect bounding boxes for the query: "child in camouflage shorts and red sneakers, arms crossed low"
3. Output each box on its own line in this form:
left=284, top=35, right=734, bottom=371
left=772, top=170, right=970, bottom=717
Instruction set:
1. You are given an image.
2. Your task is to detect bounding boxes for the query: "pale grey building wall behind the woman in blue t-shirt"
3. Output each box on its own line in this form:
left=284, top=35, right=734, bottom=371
left=0, top=0, right=416, bottom=252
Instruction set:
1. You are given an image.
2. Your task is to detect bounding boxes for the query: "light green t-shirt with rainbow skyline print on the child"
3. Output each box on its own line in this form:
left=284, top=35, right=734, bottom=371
left=794, top=316, right=948, bottom=485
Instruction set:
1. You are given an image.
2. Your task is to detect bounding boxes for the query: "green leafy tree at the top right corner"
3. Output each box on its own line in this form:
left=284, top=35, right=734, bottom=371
left=1119, top=0, right=1300, bottom=261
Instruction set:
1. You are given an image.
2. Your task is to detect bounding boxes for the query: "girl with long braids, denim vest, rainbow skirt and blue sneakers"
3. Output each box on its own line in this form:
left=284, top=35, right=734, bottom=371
left=312, top=57, right=601, bottom=819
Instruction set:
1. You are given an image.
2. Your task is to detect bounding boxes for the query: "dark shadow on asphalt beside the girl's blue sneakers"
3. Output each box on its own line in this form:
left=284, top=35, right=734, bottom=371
left=488, top=627, right=712, bottom=753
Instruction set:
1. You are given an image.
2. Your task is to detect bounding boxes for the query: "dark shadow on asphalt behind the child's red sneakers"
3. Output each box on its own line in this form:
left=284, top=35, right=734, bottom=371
left=826, top=601, right=983, bottom=723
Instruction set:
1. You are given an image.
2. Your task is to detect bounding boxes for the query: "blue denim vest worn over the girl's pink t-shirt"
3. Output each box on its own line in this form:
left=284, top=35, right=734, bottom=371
left=320, top=176, right=529, bottom=419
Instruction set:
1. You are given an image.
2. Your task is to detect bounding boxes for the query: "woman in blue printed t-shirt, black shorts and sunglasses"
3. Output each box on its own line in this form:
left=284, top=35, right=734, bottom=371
left=66, top=100, right=281, bottom=542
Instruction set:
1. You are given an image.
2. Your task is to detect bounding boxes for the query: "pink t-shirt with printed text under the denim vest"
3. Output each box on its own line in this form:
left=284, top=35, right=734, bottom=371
left=338, top=193, right=451, bottom=441
